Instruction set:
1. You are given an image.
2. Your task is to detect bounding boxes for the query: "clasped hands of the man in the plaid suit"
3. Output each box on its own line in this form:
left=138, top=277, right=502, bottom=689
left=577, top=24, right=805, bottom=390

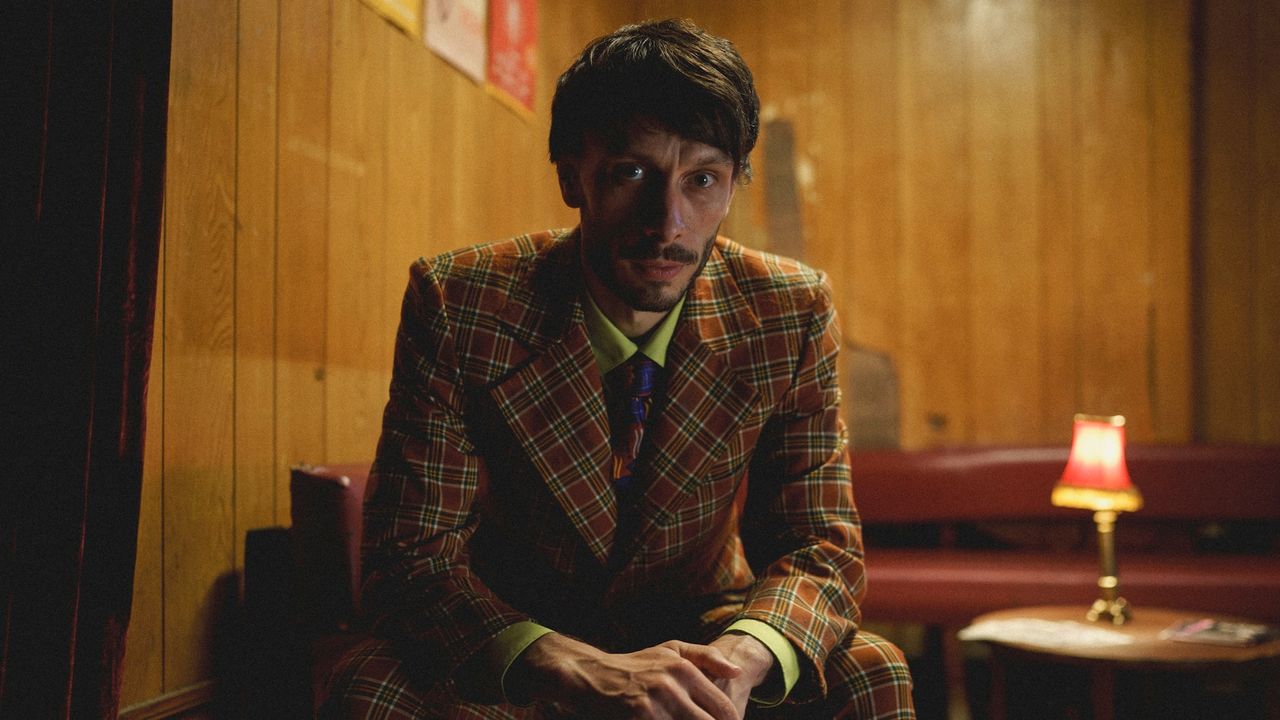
left=506, top=625, right=773, bottom=720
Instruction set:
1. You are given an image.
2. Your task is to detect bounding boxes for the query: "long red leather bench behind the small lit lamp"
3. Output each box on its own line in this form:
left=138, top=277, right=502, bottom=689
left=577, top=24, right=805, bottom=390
left=852, top=445, right=1280, bottom=626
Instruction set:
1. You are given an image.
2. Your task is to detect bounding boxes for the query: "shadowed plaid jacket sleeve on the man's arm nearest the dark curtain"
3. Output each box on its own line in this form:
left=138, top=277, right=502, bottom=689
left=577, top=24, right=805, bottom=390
left=362, top=260, right=527, bottom=694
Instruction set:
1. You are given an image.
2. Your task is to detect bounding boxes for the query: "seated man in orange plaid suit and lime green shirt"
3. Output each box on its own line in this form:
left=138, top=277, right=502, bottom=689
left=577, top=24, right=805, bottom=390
left=330, top=20, right=914, bottom=720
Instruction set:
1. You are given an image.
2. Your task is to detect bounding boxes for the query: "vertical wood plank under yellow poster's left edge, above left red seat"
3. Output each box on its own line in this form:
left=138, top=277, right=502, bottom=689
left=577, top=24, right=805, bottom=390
left=324, top=0, right=394, bottom=462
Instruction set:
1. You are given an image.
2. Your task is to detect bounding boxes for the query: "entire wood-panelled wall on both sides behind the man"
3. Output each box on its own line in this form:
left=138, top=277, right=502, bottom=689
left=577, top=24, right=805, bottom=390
left=124, top=0, right=1280, bottom=705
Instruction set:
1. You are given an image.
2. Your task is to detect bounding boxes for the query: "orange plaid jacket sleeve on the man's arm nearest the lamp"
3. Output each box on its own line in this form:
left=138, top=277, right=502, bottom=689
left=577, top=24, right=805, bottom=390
left=739, top=274, right=865, bottom=702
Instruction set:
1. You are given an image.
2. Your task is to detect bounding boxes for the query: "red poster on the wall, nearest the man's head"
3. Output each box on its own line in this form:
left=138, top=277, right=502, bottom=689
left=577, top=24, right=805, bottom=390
left=488, top=0, right=538, bottom=117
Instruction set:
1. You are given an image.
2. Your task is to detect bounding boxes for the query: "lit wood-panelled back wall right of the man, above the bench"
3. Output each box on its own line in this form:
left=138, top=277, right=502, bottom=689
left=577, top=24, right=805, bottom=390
left=645, top=0, right=1192, bottom=447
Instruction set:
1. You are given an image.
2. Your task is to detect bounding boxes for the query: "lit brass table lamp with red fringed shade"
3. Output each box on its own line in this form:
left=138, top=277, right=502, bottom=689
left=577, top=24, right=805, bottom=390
left=1051, top=415, right=1142, bottom=625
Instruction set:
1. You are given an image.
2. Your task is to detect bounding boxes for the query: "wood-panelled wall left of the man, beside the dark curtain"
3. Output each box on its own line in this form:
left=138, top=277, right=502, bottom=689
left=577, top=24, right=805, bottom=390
left=123, top=0, right=631, bottom=706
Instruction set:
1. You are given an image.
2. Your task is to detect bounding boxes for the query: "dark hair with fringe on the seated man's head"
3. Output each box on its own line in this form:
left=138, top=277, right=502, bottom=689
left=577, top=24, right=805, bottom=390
left=549, top=19, right=760, bottom=181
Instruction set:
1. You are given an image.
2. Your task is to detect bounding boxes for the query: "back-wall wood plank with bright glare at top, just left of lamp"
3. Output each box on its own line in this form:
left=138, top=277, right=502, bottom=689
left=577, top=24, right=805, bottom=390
left=965, top=1, right=1042, bottom=443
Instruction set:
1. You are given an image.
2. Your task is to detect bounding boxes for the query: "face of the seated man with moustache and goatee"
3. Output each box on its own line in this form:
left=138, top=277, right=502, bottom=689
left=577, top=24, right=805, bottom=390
left=558, top=122, right=735, bottom=320
